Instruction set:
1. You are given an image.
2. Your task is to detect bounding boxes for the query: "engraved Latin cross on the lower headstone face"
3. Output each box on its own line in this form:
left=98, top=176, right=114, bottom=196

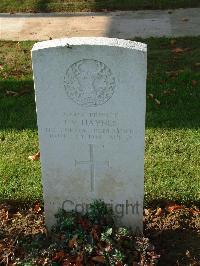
left=75, top=144, right=109, bottom=192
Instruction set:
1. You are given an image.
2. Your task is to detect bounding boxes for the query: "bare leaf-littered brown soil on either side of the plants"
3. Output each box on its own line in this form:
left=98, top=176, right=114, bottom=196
left=0, top=202, right=200, bottom=266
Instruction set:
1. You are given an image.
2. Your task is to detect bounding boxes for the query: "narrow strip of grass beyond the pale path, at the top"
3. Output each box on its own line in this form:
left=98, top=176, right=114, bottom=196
left=0, top=0, right=200, bottom=12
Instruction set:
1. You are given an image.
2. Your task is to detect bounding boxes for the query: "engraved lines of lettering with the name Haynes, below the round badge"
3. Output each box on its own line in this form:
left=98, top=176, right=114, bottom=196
left=40, top=112, right=135, bottom=143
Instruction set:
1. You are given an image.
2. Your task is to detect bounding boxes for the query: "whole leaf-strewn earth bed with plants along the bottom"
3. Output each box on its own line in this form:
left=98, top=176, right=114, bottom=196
left=0, top=202, right=200, bottom=266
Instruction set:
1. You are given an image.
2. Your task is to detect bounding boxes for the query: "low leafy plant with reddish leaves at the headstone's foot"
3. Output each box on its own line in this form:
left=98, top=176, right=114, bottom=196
left=0, top=201, right=159, bottom=266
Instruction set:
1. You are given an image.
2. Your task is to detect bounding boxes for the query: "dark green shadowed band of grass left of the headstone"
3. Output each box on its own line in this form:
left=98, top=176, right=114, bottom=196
left=0, top=80, right=37, bottom=130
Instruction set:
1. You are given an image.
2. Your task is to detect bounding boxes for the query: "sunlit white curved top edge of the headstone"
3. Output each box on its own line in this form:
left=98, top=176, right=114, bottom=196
left=32, top=37, right=147, bottom=52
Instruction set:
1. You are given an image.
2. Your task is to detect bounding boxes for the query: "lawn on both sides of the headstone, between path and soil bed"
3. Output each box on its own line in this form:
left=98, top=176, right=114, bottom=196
left=0, top=37, right=200, bottom=206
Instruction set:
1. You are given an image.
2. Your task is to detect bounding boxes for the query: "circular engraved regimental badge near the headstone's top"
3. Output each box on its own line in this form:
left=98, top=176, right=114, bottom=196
left=64, top=59, right=116, bottom=107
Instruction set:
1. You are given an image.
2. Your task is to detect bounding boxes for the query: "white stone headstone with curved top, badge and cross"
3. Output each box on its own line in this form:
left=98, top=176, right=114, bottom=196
left=32, top=38, right=147, bottom=233
